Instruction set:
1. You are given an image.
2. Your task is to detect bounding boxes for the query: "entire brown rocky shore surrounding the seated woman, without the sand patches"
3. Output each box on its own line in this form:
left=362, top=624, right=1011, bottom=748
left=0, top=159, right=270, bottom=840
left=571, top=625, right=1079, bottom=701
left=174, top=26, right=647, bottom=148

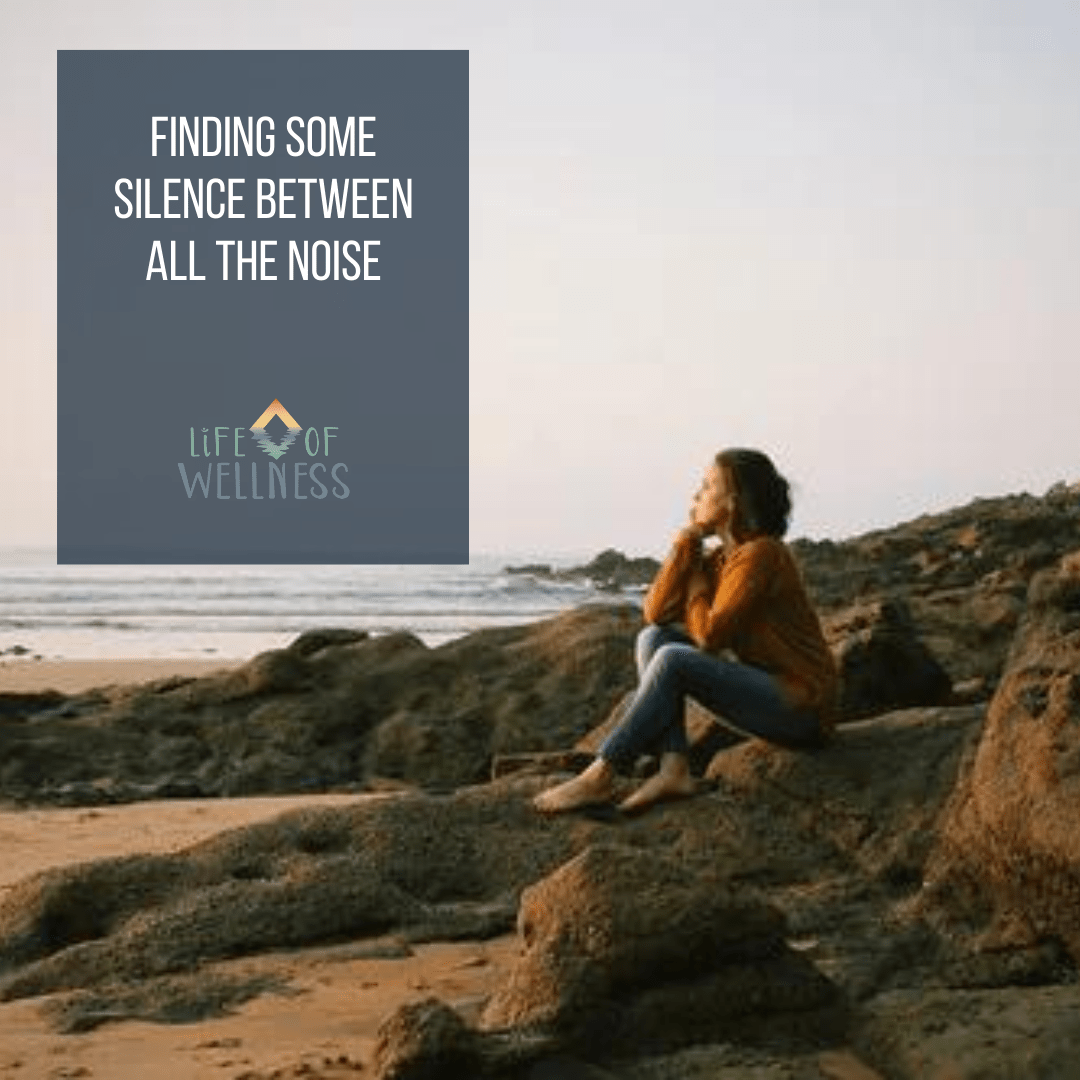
left=0, top=486, right=1080, bottom=1080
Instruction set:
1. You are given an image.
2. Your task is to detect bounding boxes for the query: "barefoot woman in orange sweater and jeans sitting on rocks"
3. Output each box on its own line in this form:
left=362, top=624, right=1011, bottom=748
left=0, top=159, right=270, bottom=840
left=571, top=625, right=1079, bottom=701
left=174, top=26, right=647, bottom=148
left=535, top=449, right=837, bottom=813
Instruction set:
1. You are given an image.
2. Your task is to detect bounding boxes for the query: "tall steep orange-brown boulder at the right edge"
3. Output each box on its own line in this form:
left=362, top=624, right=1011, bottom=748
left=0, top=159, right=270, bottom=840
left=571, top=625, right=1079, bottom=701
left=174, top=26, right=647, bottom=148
left=924, top=552, right=1080, bottom=958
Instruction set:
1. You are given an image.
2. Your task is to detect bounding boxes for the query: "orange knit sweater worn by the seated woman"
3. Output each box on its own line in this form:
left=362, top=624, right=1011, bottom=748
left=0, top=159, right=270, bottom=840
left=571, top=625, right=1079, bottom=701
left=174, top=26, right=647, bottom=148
left=644, top=534, right=838, bottom=729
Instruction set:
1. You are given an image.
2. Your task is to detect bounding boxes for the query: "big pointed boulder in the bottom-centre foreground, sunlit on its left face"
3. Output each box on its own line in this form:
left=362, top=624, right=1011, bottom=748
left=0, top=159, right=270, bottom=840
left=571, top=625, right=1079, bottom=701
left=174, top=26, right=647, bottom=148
left=481, top=843, right=834, bottom=1056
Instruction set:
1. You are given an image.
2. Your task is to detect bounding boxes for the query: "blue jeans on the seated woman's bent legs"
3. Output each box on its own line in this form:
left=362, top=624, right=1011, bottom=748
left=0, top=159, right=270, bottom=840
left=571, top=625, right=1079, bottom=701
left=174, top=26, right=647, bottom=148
left=598, top=624, right=822, bottom=772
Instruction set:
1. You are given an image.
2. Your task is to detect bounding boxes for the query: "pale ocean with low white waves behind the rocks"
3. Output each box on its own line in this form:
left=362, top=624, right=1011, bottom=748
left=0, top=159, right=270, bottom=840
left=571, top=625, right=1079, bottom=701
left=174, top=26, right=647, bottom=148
left=0, top=549, right=640, bottom=660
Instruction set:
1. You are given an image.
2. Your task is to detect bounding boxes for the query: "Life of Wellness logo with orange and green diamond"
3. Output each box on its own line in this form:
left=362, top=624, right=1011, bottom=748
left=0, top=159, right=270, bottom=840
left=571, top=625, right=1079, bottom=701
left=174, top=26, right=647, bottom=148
left=177, top=397, right=349, bottom=501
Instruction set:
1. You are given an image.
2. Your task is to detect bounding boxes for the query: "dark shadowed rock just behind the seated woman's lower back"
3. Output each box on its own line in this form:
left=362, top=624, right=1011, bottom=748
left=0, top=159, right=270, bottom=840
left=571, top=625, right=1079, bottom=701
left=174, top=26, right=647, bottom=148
left=823, top=599, right=951, bottom=720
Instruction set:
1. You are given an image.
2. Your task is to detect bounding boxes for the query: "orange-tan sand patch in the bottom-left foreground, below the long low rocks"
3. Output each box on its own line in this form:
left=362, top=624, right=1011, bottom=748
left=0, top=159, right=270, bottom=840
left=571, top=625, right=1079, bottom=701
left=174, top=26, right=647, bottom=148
left=0, top=939, right=516, bottom=1080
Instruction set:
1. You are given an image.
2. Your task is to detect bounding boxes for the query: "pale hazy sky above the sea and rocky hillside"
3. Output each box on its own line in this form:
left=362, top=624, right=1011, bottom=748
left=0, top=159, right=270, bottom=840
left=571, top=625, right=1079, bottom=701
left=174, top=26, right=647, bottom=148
left=0, top=0, right=1080, bottom=554
